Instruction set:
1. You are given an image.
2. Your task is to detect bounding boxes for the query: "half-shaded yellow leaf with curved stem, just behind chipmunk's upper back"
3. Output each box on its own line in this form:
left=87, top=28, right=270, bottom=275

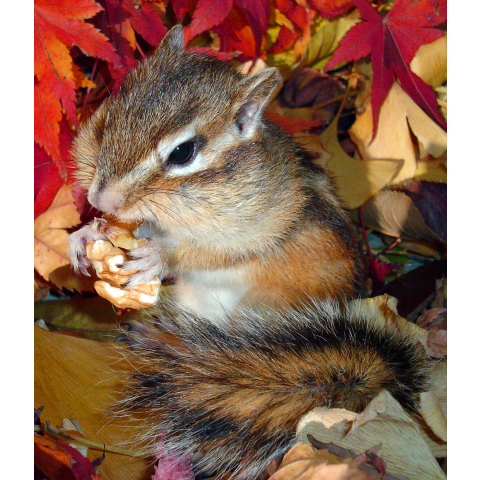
left=320, top=118, right=403, bottom=209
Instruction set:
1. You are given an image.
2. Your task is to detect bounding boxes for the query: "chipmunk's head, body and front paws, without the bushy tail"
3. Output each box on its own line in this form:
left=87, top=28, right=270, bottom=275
left=69, top=26, right=362, bottom=323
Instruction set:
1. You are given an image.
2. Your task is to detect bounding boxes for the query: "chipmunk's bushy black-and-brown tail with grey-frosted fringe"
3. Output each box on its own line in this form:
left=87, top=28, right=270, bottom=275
left=115, top=302, right=428, bottom=480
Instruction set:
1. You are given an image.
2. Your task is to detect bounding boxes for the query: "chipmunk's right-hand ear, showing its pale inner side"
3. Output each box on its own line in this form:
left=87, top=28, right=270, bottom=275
left=236, top=68, right=282, bottom=137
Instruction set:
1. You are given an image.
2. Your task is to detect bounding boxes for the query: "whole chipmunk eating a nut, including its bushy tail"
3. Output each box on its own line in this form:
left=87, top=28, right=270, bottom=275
left=66, top=26, right=446, bottom=480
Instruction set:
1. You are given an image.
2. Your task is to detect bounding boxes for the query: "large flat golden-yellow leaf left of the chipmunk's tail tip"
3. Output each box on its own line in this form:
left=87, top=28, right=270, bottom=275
left=33, top=326, right=153, bottom=480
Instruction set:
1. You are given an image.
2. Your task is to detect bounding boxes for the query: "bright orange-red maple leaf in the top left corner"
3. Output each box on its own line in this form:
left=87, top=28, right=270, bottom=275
left=33, top=0, right=118, bottom=160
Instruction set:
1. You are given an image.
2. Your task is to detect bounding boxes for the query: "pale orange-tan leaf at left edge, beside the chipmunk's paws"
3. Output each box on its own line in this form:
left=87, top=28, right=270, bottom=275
left=33, top=185, right=80, bottom=280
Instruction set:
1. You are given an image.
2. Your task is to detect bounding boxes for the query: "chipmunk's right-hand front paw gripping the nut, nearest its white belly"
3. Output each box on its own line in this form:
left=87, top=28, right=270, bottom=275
left=122, top=241, right=167, bottom=289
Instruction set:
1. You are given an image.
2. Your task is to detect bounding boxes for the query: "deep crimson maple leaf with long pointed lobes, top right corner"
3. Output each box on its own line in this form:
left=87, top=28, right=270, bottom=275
left=325, top=0, right=447, bottom=136
